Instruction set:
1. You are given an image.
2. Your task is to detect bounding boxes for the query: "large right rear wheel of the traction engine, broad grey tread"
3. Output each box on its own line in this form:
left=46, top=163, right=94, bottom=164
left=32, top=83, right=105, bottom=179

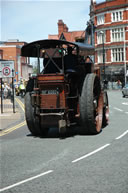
left=80, top=73, right=103, bottom=134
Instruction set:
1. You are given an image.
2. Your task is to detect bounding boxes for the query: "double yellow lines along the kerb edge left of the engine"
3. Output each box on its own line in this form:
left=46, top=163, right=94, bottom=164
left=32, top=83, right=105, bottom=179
left=0, top=98, right=26, bottom=136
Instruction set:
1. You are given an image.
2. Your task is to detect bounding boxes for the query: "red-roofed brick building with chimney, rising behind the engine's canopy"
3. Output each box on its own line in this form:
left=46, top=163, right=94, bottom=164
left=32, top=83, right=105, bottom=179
left=48, top=20, right=85, bottom=42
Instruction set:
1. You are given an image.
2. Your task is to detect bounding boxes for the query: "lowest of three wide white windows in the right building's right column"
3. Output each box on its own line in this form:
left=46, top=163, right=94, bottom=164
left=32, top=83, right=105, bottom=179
left=112, top=48, right=124, bottom=62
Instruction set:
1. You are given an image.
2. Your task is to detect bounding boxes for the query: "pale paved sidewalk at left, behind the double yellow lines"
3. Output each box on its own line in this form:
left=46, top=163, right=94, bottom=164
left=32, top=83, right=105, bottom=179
left=0, top=98, right=24, bottom=131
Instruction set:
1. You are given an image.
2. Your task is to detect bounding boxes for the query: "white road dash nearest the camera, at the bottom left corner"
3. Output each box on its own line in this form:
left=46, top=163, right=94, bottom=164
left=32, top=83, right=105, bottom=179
left=0, top=170, right=53, bottom=192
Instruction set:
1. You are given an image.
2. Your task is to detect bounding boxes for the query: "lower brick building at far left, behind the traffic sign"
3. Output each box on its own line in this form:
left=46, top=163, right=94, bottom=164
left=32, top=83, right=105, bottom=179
left=0, top=40, right=32, bottom=82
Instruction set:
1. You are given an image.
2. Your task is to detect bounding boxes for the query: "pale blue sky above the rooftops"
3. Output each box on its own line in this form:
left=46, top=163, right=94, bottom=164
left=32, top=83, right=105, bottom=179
left=0, top=0, right=104, bottom=43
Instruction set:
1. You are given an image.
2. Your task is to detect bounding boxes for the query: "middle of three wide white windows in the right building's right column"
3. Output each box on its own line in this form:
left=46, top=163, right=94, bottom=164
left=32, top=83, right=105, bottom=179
left=111, top=28, right=124, bottom=42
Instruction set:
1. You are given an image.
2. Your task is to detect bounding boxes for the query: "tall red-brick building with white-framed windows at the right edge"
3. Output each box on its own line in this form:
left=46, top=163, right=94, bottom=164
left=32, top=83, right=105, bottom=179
left=90, top=0, right=128, bottom=84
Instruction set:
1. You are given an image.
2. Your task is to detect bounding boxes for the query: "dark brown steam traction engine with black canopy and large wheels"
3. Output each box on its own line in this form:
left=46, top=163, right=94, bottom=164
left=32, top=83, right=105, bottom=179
left=22, top=40, right=109, bottom=135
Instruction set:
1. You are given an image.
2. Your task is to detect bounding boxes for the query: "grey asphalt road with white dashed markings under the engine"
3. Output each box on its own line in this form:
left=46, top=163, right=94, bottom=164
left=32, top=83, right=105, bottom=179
left=0, top=91, right=128, bottom=193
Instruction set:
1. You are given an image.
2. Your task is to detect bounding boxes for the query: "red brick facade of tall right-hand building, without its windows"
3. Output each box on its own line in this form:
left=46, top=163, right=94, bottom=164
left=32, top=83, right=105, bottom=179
left=90, top=0, right=128, bottom=74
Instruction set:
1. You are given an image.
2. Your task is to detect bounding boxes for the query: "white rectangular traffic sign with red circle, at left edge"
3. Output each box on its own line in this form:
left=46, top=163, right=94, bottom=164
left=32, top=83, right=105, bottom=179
left=0, top=60, right=15, bottom=78
